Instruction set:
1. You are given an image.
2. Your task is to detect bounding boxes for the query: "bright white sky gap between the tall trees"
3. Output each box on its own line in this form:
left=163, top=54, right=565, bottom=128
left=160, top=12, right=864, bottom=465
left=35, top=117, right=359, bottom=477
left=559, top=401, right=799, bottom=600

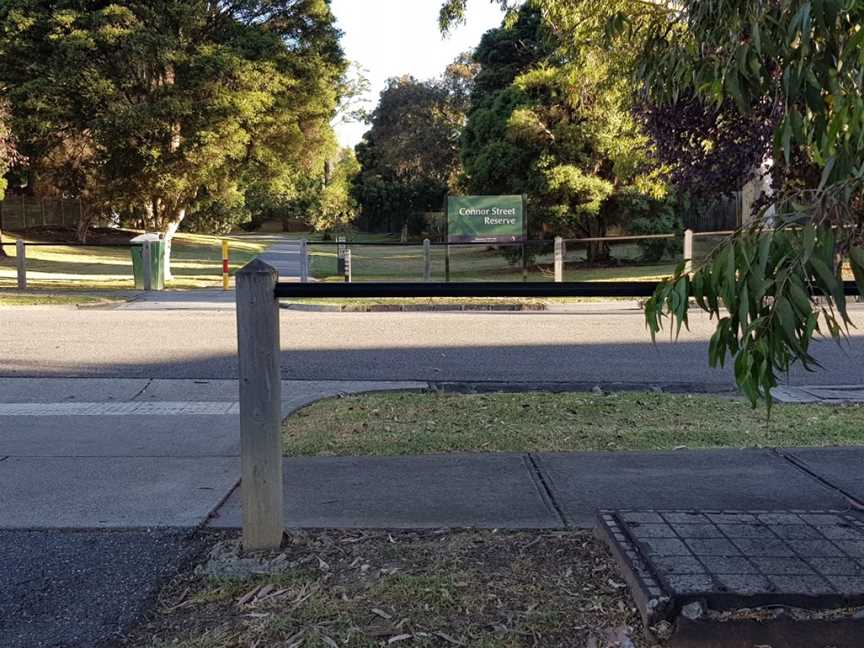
left=331, top=0, right=504, bottom=147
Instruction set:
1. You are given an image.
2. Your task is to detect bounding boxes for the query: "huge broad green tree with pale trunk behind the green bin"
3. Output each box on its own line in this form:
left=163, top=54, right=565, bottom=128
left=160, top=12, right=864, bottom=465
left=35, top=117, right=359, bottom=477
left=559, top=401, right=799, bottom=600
left=0, top=0, right=345, bottom=268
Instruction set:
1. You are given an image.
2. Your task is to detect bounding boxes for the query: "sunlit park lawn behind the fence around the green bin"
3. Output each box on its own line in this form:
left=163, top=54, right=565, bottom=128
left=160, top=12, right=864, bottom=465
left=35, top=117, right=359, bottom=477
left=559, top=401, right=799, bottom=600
left=0, top=233, right=267, bottom=291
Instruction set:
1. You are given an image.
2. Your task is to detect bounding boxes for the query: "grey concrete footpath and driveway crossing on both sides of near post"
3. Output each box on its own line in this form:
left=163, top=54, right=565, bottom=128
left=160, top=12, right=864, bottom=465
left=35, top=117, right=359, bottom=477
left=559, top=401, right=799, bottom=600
left=0, top=379, right=864, bottom=529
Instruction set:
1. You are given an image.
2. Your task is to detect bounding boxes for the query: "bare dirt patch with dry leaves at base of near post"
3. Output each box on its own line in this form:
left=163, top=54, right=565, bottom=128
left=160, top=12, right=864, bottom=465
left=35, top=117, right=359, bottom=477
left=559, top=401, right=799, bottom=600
left=126, top=531, right=655, bottom=648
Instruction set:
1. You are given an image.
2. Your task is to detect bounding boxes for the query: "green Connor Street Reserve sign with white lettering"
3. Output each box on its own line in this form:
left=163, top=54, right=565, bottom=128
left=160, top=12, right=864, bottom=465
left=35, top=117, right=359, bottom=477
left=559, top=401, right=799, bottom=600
left=447, top=196, right=527, bottom=243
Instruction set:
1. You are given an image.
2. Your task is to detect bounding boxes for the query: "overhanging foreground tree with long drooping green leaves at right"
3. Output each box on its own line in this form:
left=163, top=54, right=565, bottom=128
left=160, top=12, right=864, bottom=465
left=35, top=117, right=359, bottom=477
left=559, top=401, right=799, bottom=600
left=442, top=0, right=864, bottom=403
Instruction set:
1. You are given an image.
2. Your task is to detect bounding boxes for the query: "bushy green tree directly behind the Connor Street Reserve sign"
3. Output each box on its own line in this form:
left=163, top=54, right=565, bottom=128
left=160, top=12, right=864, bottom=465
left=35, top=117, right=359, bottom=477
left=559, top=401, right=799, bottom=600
left=462, top=1, right=664, bottom=260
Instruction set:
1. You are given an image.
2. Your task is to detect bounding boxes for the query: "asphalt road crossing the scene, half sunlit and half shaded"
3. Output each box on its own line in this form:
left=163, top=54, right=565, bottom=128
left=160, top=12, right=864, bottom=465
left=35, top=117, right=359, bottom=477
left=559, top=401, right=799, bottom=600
left=0, top=305, right=864, bottom=389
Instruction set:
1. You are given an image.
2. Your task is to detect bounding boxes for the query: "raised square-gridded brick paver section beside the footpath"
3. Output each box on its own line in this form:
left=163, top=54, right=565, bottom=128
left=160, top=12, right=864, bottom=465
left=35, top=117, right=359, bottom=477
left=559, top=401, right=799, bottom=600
left=600, top=511, right=864, bottom=624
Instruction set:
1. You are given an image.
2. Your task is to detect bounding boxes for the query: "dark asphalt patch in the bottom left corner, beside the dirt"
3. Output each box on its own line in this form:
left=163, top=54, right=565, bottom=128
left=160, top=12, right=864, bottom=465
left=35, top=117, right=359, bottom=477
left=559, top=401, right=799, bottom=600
left=0, top=529, right=206, bottom=648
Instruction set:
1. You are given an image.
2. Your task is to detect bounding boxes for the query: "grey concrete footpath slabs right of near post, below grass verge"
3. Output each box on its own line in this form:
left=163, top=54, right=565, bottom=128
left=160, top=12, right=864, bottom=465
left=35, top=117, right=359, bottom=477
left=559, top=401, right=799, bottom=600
left=211, top=448, right=864, bottom=529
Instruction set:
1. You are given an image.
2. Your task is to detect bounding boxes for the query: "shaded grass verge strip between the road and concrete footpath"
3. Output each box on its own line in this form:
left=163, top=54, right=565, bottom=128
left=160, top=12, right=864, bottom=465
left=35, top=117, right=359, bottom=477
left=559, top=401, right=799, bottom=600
left=283, top=392, right=864, bottom=456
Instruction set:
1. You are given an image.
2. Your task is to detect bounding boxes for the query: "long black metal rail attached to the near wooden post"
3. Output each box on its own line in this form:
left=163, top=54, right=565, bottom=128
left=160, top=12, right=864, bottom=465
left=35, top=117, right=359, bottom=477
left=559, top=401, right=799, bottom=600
left=276, top=281, right=858, bottom=299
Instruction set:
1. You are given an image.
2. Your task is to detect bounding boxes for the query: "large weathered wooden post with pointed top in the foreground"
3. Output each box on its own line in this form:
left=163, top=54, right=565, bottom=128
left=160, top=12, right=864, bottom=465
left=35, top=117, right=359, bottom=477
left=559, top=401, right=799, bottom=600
left=235, top=259, right=284, bottom=551
